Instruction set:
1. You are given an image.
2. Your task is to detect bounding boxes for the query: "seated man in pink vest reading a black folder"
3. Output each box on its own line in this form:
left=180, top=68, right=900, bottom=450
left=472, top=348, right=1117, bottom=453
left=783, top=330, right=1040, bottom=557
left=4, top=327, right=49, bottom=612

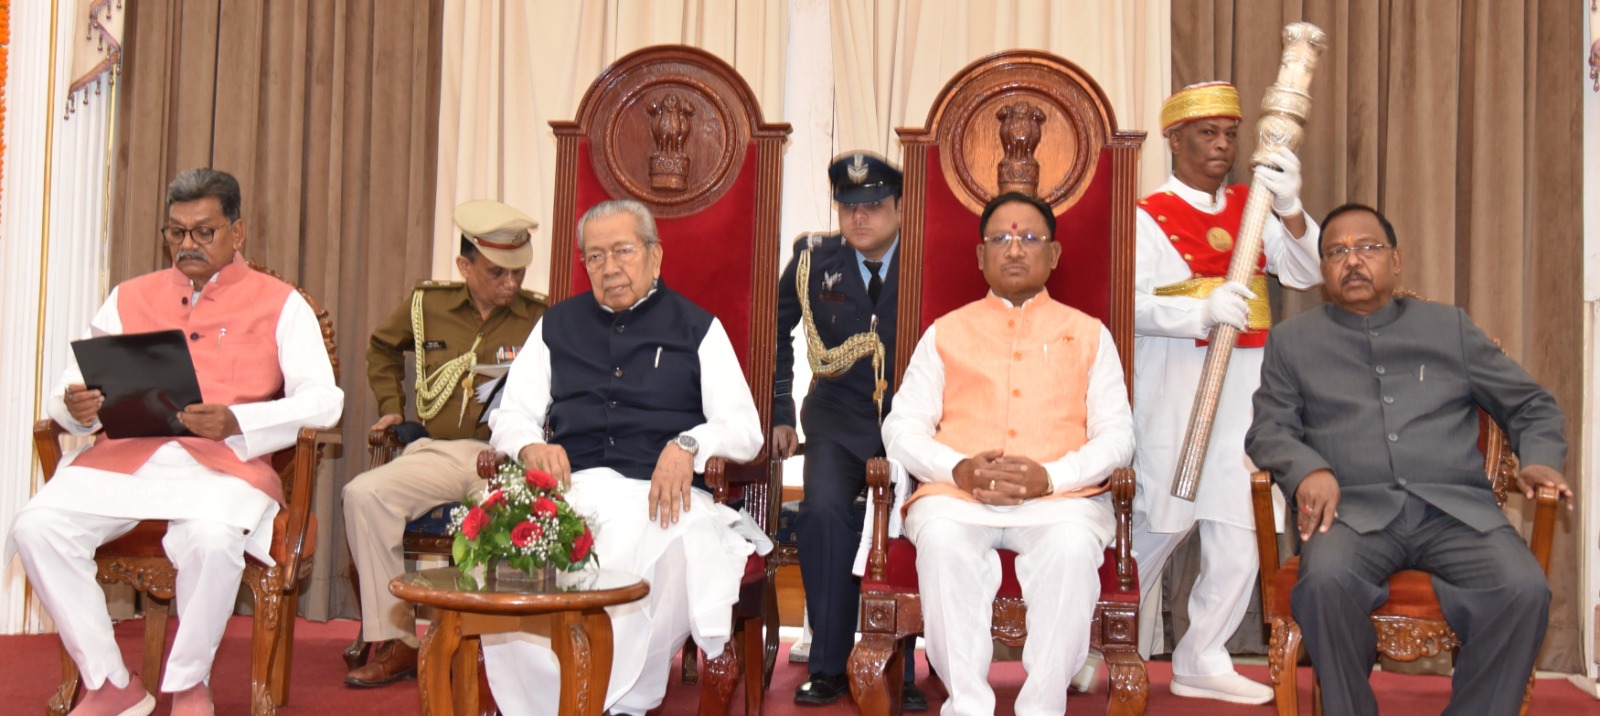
left=3, top=169, right=344, bottom=716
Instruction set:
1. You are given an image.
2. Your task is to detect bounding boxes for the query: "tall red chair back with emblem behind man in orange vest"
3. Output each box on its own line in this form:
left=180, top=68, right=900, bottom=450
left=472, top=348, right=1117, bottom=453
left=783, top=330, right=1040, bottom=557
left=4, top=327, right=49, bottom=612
left=894, top=50, right=1144, bottom=395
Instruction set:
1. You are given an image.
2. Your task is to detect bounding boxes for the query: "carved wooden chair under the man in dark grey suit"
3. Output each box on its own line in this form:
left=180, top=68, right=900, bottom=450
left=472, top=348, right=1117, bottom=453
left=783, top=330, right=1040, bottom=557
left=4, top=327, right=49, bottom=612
left=1250, top=305, right=1560, bottom=716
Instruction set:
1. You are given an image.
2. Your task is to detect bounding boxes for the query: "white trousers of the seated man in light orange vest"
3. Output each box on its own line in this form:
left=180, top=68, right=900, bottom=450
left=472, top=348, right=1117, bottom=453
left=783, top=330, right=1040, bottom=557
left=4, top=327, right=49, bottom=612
left=906, top=497, right=1110, bottom=716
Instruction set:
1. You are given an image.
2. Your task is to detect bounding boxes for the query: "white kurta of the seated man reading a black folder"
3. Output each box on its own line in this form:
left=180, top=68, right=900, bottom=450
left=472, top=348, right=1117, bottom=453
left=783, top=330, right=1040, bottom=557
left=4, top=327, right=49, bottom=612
left=6, top=281, right=344, bottom=564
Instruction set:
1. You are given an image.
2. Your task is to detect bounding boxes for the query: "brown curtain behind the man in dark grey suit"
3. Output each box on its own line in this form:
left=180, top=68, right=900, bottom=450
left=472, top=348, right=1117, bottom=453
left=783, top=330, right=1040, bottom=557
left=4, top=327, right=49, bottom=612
left=1173, top=0, right=1587, bottom=671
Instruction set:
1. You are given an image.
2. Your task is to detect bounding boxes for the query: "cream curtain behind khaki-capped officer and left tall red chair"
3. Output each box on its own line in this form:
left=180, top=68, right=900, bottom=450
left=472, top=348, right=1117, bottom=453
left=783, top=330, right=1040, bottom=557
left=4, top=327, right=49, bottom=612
left=435, top=0, right=787, bottom=290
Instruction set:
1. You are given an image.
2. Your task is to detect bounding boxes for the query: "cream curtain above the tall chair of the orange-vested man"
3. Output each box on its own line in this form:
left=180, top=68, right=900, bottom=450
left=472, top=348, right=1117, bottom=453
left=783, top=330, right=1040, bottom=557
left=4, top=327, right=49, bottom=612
left=832, top=0, right=1170, bottom=189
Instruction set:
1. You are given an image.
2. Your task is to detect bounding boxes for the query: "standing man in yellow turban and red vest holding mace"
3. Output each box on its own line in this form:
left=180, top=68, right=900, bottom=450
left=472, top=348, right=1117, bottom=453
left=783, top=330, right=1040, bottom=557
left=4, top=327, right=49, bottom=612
left=1133, top=82, right=1318, bottom=703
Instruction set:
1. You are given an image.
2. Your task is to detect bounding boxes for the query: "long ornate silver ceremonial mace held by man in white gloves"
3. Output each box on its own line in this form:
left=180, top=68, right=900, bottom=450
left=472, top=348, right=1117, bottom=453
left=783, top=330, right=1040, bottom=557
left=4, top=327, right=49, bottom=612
left=1173, top=22, right=1328, bottom=502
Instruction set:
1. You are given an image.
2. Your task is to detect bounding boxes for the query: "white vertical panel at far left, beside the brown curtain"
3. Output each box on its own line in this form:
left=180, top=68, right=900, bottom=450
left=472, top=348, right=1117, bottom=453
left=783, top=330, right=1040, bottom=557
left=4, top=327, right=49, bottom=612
left=0, top=0, right=120, bottom=634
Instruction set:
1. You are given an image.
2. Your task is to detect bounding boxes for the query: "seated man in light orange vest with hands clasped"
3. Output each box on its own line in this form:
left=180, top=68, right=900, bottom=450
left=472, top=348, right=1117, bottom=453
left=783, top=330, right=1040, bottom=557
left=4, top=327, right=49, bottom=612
left=883, top=193, right=1133, bottom=716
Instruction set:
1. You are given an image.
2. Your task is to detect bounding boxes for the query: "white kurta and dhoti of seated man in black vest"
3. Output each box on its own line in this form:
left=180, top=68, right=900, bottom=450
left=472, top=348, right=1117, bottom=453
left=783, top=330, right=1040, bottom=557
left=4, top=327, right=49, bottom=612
left=483, top=320, right=771, bottom=716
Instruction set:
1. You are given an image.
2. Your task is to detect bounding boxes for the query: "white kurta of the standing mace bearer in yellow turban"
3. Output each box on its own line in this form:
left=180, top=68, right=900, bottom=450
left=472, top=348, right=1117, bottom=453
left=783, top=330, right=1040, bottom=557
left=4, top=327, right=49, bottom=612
left=1133, top=177, right=1322, bottom=532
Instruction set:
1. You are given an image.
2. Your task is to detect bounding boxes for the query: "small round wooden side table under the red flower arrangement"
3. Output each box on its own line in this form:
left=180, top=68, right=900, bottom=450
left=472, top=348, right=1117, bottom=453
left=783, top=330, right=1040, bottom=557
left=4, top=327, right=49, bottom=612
left=389, top=567, right=650, bottom=716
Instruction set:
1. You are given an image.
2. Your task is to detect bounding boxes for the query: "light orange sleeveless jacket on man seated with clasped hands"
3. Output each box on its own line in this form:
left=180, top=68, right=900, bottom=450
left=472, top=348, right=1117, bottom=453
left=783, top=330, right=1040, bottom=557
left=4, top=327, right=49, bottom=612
left=907, top=292, right=1101, bottom=505
